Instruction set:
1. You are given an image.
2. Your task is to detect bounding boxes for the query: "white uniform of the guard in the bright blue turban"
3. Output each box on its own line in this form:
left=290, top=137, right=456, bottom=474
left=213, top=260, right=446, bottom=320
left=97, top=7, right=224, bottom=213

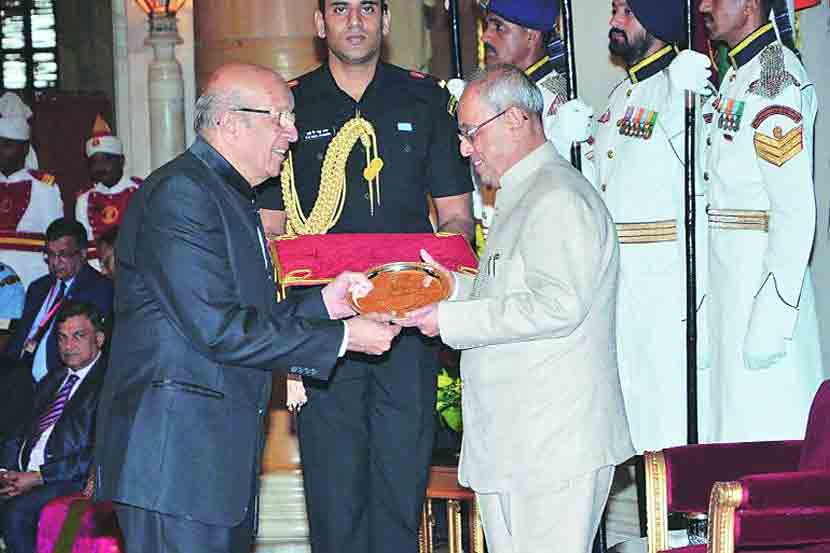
left=525, top=56, right=595, bottom=182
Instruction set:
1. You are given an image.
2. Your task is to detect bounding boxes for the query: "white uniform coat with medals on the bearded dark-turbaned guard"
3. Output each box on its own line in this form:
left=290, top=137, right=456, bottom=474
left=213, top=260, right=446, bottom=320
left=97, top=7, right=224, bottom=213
left=594, top=45, right=711, bottom=453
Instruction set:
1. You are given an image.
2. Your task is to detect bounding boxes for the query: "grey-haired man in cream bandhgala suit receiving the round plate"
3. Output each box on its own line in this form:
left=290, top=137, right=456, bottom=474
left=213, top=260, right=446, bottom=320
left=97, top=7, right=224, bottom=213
left=402, top=65, right=634, bottom=553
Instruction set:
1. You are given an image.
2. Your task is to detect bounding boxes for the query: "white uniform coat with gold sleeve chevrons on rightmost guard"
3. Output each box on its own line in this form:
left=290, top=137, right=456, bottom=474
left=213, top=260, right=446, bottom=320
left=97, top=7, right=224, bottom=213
left=702, top=24, right=826, bottom=442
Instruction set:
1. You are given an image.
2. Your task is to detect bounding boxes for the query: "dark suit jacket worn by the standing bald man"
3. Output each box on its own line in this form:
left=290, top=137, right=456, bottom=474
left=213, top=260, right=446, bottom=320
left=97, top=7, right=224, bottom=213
left=95, top=139, right=344, bottom=526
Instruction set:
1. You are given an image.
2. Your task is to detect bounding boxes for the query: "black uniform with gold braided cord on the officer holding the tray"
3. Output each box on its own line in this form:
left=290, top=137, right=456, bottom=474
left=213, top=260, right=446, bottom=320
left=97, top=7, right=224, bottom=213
left=261, top=63, right=472, bottom=553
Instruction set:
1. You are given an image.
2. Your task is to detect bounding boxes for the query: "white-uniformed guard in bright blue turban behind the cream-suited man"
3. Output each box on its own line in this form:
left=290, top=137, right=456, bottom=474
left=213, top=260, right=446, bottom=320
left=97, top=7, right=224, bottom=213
left=479, top=0, right=594, bottom=180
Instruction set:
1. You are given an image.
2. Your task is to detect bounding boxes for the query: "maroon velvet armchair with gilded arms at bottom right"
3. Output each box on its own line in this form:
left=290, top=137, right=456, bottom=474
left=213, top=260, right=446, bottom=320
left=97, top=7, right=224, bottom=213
left=645, top=380, right=830, bottom=553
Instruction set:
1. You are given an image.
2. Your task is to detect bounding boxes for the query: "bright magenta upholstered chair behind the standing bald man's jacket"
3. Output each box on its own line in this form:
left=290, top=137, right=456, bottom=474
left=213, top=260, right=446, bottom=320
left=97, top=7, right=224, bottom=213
left=37, top=477, right=124, bottom=553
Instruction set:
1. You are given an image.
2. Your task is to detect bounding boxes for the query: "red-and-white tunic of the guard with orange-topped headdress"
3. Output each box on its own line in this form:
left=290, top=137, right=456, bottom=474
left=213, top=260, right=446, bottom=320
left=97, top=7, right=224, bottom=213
left=75, top=176, right=142, bottom=239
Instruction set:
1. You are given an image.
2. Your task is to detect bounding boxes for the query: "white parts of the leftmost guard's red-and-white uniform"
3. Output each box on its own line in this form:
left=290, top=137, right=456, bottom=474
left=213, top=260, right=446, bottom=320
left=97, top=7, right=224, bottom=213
left=0, top=168, right=63, bottom=287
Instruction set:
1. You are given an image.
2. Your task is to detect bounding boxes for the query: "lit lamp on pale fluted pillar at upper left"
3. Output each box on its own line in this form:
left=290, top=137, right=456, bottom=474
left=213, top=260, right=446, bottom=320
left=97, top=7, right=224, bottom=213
left=135, top=0, right=186, bottom=169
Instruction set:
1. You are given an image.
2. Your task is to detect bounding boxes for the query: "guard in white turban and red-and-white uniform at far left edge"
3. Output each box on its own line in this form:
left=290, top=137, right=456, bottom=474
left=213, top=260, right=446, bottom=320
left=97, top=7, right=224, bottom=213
left=0, top=92, right=63, bottom=286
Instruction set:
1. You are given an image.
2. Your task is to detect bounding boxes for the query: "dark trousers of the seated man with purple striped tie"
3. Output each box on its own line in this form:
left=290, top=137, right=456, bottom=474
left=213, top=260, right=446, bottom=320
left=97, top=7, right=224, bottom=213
left=0, top=481, right=84, bottom=553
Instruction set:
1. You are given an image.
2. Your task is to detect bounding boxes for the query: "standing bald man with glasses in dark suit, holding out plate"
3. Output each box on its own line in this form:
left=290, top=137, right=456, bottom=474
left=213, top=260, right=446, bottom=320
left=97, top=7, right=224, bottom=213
left=95, top=64, right=400, bottom=553
